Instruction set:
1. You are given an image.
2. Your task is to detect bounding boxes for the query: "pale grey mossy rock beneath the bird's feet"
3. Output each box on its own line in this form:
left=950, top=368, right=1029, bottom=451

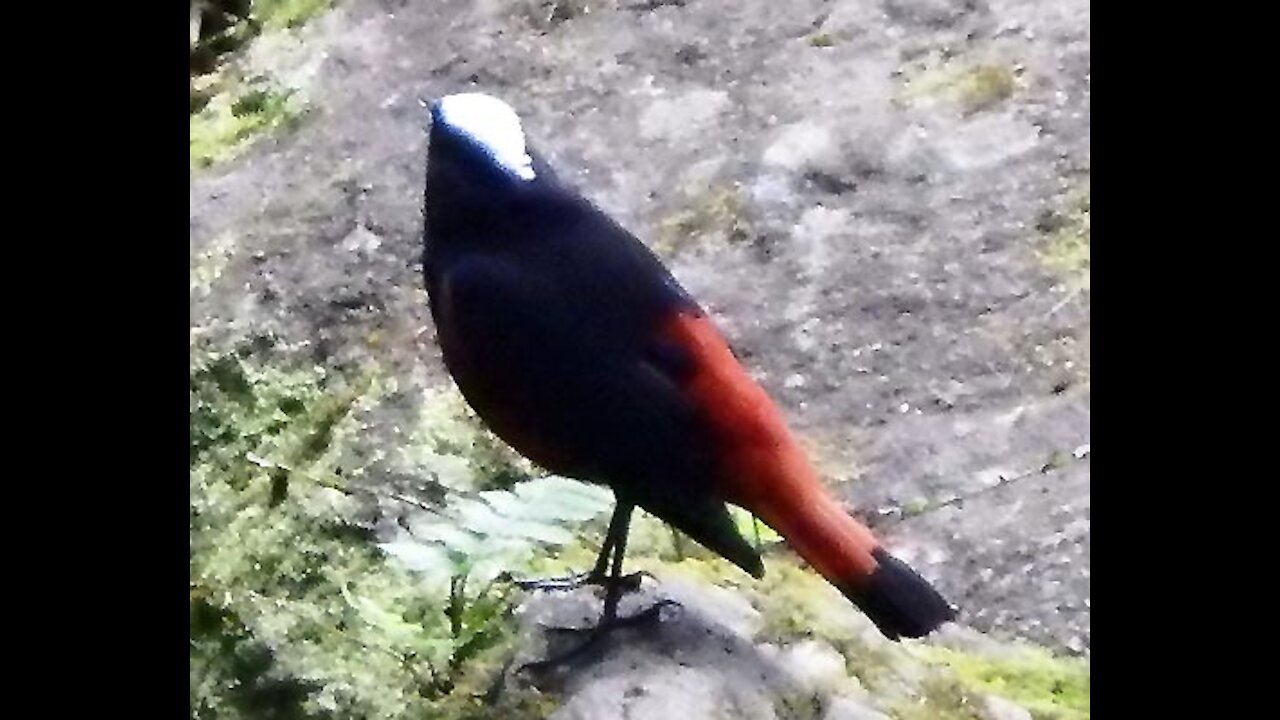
left=490, top=569, right=1087, bottom=720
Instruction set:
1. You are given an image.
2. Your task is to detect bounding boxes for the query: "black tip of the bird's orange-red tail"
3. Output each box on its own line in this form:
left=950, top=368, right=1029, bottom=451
left=845, top=548, right=956, bottom=641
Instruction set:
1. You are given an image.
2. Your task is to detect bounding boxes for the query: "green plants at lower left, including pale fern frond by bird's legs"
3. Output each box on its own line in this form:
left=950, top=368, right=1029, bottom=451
left=191, top=352, right=611, bottom=719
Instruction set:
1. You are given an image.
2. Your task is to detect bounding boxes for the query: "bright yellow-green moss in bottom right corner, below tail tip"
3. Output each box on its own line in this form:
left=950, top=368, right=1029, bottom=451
left=918, top=647, right=1089, bottom=720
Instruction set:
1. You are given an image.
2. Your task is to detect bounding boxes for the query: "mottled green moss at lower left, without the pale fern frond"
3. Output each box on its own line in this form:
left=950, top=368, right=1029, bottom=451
left=189, top=348, right=578, bottom=720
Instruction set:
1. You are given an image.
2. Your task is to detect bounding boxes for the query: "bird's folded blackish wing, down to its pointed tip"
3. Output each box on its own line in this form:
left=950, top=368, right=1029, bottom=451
left=434, top=249, right=763, bottom=575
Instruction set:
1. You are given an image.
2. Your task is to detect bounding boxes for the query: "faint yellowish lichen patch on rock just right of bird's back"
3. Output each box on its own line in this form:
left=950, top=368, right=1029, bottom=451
left=653, top=186, right=754, bottom=258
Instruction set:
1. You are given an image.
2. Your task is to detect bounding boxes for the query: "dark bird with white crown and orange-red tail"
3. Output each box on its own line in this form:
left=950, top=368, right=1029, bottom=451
left=422, top=91, right=959, bottom=655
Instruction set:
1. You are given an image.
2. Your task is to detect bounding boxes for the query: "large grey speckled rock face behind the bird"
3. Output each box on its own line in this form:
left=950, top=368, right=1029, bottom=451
left=191, top=0, right=1089, bottom=661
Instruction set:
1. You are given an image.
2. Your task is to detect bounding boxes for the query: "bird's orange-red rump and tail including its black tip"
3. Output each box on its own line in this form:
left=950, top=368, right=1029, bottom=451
left=666, top=314, right=955, bottom=639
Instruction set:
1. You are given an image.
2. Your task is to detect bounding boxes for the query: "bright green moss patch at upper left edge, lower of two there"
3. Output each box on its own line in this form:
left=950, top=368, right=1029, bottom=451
left=189, top=81, right=303, bottom=168
